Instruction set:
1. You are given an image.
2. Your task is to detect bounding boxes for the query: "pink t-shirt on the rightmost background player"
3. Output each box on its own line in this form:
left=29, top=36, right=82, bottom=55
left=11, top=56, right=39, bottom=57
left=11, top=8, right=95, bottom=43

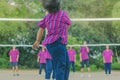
left=102, top=49, right=113, bottom=63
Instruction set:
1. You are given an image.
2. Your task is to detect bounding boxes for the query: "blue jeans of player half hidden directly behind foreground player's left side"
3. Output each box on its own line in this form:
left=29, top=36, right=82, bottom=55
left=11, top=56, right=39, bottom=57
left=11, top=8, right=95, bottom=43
left=45, top=59, right=55, bottom=79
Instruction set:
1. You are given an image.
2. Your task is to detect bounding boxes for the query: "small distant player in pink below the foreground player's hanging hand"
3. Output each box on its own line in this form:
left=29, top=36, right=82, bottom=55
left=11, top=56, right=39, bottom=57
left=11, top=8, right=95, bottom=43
left=37, top=47, right=46, bottom=75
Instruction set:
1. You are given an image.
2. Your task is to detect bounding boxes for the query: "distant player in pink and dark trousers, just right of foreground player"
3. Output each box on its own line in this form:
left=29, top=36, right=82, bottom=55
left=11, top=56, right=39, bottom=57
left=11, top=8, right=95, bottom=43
left=68, top=46, right=76, bottom=72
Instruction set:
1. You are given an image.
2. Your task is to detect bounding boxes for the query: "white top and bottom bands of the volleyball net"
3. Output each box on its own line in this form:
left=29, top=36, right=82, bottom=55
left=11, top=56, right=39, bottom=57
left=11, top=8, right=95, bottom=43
left=0, top=18, right=120, bottom=47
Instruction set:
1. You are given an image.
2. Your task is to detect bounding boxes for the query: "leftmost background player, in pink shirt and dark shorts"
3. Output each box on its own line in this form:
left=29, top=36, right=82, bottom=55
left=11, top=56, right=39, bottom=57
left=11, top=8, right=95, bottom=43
left=9, top=45, right=19, bottom=76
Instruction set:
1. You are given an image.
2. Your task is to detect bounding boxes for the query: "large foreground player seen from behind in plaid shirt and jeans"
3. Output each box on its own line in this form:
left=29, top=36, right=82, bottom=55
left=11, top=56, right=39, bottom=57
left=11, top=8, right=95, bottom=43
left=32, top=0, right=71, bottom=80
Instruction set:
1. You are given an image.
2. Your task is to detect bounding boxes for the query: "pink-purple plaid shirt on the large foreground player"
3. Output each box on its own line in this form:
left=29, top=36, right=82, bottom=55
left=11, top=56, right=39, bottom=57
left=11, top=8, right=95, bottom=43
left=37, top=10, right=71, bottom=45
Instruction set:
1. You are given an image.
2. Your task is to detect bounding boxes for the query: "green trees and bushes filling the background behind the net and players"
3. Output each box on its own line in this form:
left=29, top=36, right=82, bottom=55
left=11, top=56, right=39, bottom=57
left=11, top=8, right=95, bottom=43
left=0, top=0, right=120, bottom=71
